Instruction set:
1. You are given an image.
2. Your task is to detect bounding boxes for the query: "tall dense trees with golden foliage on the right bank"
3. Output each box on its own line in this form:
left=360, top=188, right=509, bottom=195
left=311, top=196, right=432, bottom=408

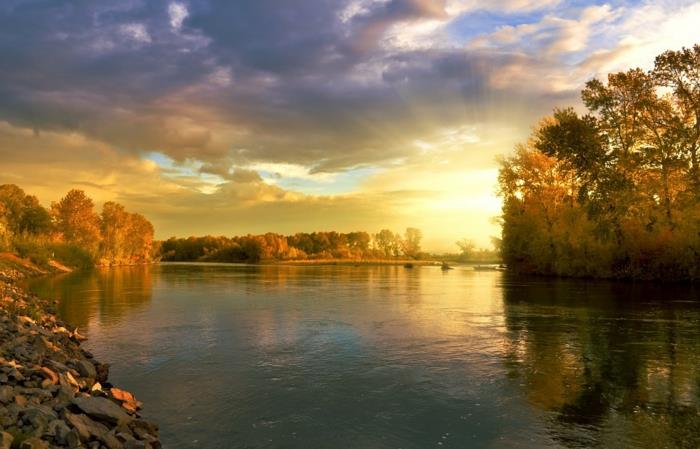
left=499, top=45, right=700, bottom=280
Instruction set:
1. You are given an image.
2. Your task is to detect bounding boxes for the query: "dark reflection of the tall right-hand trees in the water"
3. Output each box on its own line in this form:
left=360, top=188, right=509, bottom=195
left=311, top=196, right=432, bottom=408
left=504, top=280, right=700, bottom=448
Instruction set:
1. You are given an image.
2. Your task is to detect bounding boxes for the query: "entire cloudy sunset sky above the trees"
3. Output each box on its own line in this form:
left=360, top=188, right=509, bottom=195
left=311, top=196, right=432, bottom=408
left=0, top=0, right=700, bottom=252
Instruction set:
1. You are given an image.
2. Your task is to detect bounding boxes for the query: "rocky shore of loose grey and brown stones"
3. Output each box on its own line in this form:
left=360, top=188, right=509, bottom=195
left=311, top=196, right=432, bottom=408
left=0, top=269, right=161, bottom=449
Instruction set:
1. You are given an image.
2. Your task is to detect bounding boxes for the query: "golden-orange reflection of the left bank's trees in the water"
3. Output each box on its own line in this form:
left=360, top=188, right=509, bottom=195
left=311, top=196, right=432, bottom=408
left=31, top=265, right=153, bottom=329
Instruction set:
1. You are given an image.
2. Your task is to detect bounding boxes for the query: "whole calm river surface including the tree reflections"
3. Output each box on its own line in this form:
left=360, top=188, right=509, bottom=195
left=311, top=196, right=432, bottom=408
left=24, top=264, right=700, bottom=449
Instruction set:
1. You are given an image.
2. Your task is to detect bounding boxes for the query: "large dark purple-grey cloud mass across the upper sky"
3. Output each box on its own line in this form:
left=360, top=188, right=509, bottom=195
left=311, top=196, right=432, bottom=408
left=0, top=0, right=576, bottom=173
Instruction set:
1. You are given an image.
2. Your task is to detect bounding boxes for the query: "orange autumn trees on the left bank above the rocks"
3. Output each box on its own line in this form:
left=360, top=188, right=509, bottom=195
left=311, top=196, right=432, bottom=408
left=0, top=184, right=153, bottom=267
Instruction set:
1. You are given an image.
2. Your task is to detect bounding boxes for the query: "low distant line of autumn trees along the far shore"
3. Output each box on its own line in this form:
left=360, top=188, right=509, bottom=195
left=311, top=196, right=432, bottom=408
left=160, top=228, right=424, bottom=262
